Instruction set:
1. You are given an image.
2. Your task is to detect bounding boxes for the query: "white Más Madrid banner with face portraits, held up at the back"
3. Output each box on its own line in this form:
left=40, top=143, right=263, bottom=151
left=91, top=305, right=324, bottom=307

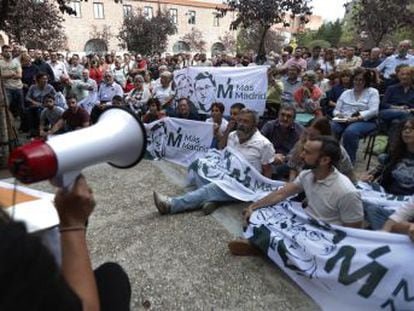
left=174, top=66, right=268, bottom=115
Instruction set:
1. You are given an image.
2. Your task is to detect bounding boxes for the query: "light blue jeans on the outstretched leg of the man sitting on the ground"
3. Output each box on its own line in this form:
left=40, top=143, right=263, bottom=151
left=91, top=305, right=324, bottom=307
left=170, top=177, right=237, bottom=214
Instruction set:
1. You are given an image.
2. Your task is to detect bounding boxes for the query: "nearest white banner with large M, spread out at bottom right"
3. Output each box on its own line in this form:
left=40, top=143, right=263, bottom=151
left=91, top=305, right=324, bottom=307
left=245, top=202, right=414, bottom=311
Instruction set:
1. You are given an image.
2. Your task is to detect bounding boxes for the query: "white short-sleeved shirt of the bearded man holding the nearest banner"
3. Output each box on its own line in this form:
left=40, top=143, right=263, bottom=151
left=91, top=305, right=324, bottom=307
left=293, top=168, right=364, bottom=225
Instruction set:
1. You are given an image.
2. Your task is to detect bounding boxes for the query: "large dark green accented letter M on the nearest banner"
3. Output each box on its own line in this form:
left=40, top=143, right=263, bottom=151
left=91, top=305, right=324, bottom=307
left=325, top=245, right=391, bottom=298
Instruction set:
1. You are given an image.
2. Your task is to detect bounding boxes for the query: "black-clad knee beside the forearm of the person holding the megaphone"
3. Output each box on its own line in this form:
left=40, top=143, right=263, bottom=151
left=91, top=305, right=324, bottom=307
left=94, top=262, right=131, bottom=311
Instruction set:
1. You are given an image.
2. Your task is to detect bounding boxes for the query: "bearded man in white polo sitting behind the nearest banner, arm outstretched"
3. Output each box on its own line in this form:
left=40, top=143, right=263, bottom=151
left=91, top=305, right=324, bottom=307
left=229, top=136, right=364, bottom=256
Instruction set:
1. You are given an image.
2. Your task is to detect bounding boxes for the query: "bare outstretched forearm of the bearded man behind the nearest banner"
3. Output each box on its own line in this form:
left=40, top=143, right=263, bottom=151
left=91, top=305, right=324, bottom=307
left=243, top=183, right=303, bottom=222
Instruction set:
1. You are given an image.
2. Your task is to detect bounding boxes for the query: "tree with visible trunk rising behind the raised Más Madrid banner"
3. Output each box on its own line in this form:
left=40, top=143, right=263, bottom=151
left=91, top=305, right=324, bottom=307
left=217, top=0, right=312, bottom=62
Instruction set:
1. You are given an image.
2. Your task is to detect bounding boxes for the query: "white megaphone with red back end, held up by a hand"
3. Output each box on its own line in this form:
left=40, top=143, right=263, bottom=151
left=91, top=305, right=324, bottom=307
left=8, top=107, right=147, bottom=187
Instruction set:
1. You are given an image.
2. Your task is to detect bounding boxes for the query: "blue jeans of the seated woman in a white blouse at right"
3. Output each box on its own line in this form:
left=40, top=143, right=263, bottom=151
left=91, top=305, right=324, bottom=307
left=331, top=121, right=377, bottom=164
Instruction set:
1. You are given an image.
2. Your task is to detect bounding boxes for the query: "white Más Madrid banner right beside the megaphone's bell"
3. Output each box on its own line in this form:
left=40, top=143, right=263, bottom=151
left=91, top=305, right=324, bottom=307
left=145, top=118, right=213, bottom=167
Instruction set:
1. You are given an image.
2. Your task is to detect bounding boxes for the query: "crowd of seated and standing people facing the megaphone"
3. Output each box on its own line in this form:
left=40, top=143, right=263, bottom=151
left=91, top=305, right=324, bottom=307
left=0, top=37, right=414, bottom=303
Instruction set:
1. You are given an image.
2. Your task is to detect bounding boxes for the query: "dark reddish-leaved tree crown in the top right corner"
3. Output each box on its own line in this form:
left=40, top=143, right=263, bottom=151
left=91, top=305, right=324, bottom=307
left=346, top=0, right=414, bottom=46
